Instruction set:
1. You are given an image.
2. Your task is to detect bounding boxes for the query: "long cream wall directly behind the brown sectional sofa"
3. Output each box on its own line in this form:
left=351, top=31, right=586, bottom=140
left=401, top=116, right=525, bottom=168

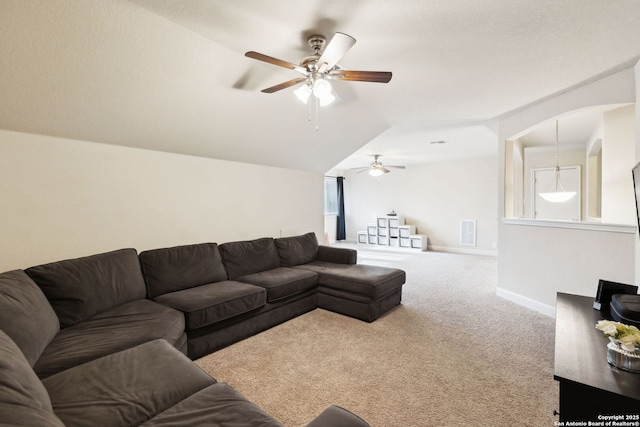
left=0, top=130, right=324, bottom=271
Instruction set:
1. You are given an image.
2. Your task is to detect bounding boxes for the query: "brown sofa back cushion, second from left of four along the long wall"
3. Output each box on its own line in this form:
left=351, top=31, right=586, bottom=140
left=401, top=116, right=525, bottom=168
left=139, top=243, right=227, bottom=298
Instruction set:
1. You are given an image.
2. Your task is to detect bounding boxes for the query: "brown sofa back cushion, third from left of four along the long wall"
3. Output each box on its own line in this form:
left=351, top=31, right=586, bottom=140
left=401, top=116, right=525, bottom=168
left=220, top=237, right=280, bottom=280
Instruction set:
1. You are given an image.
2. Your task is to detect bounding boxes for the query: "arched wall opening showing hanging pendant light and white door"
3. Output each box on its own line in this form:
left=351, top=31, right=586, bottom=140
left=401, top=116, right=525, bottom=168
left=504, top=104, right=636, bottom=225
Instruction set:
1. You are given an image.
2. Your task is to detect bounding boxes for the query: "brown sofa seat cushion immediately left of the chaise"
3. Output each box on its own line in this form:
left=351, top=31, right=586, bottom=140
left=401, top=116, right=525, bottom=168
left=238, top=267, right=318, bottom=302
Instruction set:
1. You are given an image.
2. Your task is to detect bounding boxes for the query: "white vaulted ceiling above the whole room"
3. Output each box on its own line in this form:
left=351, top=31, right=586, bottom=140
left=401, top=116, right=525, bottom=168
left=0, top=0, right=640, bottom=173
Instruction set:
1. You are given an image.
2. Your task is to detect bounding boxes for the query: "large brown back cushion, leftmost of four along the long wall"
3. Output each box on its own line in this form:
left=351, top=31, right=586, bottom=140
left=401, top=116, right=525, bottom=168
left=26, top=249, right=146, bottom=328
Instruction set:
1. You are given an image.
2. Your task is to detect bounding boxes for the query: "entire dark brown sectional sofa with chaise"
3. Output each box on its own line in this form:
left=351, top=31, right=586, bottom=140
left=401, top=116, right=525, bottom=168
left=0, top=233, right=405, bottom=427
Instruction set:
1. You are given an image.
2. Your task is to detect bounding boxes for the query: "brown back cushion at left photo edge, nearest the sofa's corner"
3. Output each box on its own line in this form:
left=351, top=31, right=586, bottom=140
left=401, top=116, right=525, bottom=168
left=0, top=270, right=60, bottom=366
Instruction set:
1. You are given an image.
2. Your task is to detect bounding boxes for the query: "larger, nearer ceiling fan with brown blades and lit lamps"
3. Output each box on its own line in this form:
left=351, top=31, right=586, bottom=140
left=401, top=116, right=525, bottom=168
left=245, top=33, right=391, bottom=105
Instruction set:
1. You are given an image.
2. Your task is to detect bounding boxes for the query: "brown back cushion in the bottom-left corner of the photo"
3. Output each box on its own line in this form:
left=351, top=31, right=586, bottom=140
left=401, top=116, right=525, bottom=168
left=0, top=330, right=64, bottom=427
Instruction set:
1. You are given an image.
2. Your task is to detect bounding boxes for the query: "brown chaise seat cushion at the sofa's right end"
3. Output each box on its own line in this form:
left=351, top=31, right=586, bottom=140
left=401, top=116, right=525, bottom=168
left=296, top=261, right=406, bottom=300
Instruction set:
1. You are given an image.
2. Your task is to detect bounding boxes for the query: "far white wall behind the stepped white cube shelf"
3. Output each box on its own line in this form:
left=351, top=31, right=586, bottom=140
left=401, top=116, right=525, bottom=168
left=345, top=157, right=498, bottom=254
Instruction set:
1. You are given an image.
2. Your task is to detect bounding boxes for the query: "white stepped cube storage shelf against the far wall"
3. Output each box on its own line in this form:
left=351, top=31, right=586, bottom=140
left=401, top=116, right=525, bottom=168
left=357, top=215, right=427, bottom=251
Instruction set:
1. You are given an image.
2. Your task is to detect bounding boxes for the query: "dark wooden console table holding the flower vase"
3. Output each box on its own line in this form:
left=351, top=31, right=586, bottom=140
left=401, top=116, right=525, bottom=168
left=553, top=293, right=640, bottom=425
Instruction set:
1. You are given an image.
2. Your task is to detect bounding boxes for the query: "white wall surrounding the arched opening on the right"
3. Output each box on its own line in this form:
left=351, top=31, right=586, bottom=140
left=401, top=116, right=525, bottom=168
left=497, top=67, right=638, bottom=314
